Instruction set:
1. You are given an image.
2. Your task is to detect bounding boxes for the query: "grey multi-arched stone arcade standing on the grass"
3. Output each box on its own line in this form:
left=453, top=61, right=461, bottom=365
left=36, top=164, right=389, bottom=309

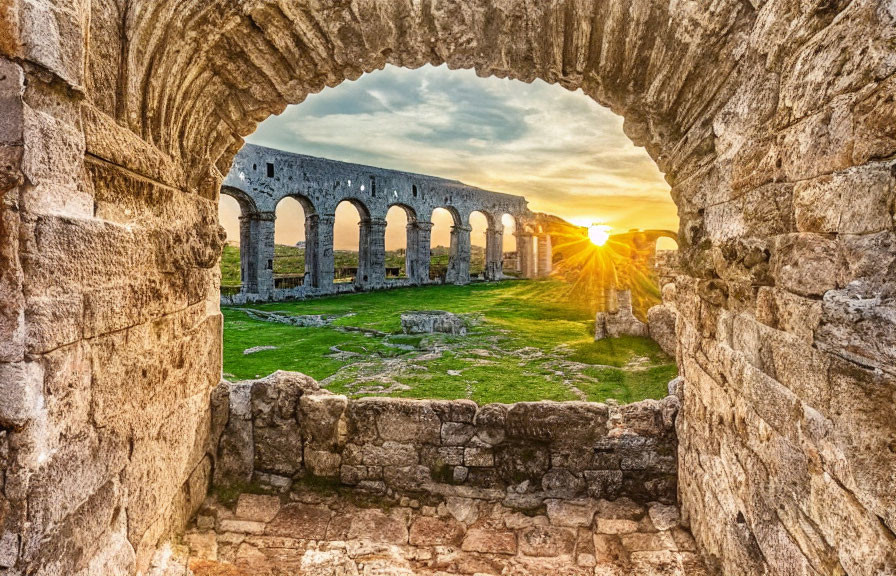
left=221, top=145, right=551, bottom=301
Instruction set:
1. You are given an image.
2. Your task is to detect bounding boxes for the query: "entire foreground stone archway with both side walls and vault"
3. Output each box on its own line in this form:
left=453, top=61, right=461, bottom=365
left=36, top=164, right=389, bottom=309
left=0, top=0, right=896, bottom=576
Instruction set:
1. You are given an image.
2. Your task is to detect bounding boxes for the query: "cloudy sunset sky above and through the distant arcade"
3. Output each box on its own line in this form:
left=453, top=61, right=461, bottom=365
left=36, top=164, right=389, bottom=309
left=221, top=66, right=678, bottom=250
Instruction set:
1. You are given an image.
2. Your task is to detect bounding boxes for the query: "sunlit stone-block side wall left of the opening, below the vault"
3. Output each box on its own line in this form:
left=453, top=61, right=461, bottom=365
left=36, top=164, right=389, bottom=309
left=0, top=6, right=224, bottom=576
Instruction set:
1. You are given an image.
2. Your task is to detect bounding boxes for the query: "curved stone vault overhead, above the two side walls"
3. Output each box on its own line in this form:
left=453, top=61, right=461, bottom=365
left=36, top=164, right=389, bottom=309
left=90, top=0, right=757, bottom=189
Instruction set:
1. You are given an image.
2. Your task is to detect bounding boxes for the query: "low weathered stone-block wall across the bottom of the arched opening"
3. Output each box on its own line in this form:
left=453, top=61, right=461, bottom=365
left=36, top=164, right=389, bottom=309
left=212, top=372, right=679, bottom=510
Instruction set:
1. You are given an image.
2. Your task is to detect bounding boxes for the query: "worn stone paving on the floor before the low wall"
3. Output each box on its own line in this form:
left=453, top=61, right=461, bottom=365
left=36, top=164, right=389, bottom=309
left=158, top=487, right=706, bottom=576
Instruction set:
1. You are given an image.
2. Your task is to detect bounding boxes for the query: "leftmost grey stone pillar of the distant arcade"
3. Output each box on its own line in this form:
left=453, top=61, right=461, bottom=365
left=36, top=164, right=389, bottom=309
left=240, top=212, right=277, bottom=298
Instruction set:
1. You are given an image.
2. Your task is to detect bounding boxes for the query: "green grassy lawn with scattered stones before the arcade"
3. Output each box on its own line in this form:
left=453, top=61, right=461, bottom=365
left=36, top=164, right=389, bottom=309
left=223, top=280, right=677, bottom=403
